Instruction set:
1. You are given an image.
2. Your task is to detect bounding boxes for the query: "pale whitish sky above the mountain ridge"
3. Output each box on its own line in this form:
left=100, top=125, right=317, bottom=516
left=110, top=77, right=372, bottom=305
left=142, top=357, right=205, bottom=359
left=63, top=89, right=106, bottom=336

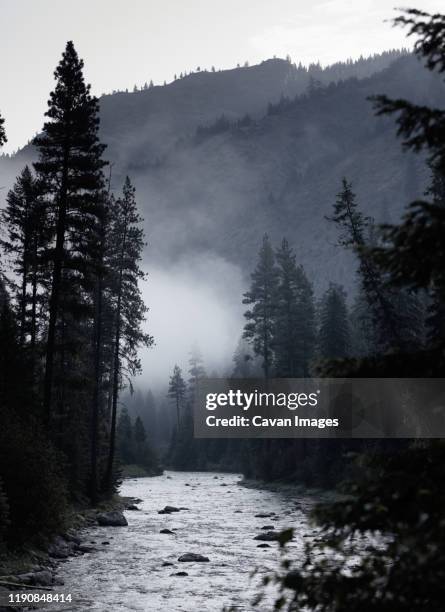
left=0, top=0, right=444, bottom=152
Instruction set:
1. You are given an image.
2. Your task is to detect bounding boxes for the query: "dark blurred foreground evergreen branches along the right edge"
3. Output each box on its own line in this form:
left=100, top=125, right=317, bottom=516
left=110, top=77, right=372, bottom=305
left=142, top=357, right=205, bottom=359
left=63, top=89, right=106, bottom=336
left=264, top=10, right=445, bottom=612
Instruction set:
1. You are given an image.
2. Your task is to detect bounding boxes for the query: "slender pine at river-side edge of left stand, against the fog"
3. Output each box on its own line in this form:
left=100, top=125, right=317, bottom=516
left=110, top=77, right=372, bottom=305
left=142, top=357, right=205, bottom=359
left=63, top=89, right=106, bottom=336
left=105, top=177, right=153, bottom=489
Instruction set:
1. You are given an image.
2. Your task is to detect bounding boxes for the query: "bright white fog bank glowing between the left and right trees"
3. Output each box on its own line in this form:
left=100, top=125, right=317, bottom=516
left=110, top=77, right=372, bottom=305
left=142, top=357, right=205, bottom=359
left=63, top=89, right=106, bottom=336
left=138, top=254, right=245, bottom=389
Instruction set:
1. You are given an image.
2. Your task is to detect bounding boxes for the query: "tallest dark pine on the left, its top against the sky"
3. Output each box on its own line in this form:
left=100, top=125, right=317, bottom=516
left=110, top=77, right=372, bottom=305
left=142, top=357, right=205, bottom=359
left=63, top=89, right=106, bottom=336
left=34, top=41, right=105, bottom=421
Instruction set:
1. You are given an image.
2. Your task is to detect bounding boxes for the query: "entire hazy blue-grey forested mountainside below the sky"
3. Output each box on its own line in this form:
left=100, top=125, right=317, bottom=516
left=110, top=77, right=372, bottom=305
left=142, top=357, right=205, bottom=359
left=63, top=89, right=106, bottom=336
left=0, top=52, right=434, bottom=294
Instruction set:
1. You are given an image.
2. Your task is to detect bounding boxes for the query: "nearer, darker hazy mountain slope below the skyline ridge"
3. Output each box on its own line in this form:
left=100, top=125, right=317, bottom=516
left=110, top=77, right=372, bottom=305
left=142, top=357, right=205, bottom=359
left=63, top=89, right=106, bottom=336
left=124, top=57, right=445, bottom=286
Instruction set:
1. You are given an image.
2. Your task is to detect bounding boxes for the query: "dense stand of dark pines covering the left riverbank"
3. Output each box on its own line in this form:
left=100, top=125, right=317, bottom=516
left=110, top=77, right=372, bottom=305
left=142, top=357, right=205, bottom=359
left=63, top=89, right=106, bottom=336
left=0, top=42, right=158, bottom=544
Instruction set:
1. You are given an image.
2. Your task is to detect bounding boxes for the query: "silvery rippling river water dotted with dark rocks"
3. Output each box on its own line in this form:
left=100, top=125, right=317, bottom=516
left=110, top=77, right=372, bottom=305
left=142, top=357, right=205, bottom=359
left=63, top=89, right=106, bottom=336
left=48, top=472, right=316, bottom=612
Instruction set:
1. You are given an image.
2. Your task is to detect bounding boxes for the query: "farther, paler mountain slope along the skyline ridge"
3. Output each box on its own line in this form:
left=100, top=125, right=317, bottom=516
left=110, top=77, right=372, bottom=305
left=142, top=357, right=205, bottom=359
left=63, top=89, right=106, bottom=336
left=0, top=51, right=404, bottom=194
